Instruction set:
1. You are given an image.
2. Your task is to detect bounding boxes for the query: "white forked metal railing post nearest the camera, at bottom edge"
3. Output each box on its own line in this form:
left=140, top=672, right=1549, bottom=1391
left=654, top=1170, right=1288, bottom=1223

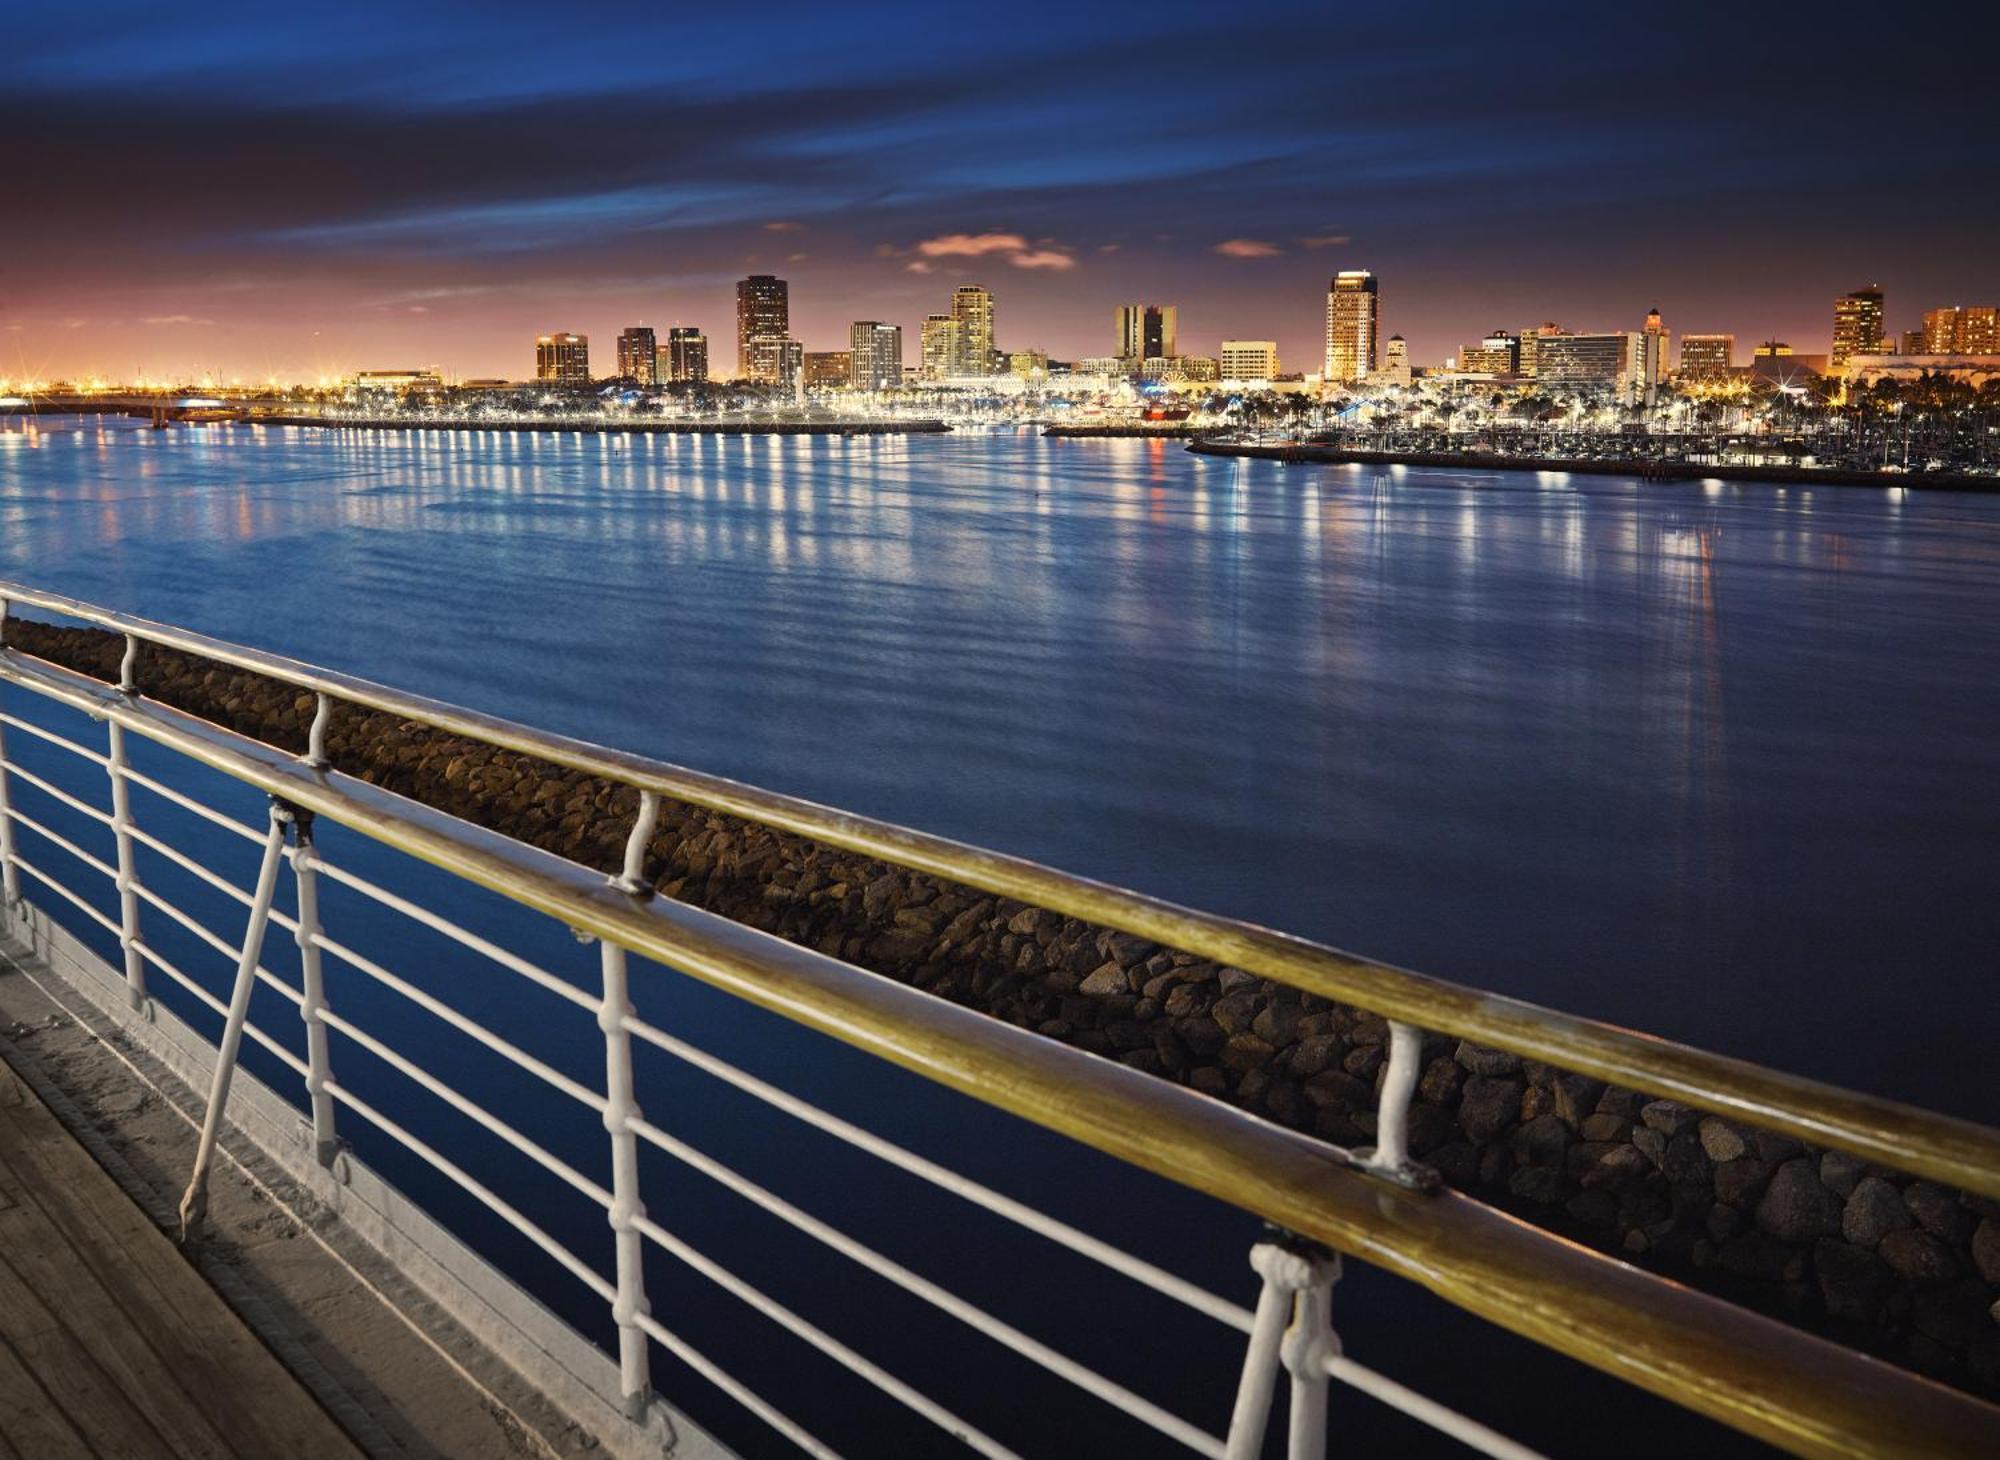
left=1224, top=1240, right=1340, bottom=1460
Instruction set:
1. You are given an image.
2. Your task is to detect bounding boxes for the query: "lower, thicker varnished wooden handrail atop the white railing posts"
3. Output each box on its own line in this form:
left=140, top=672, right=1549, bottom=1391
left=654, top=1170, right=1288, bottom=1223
left=0, top=650, right=2000, bottom=1460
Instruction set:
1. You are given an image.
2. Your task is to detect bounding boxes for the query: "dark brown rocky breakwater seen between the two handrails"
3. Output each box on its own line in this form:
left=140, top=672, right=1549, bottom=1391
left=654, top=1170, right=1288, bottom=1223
left=6, top=620, right=2000, bottom=1398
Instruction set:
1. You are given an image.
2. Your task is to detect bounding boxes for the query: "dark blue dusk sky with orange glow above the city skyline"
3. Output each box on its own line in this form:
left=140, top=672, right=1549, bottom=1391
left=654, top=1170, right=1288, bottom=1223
left=0, top=0, right=2000, bottom=380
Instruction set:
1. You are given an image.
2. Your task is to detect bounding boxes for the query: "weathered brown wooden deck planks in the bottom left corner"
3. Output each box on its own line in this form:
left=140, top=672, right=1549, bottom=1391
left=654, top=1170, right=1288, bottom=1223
left=0, top=1064, right=358, bottom=1460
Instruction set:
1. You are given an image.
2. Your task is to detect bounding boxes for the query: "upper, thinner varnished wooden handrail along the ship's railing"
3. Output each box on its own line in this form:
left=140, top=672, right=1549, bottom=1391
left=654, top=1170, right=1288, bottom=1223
left=0, top=582, right=2000, bottom=1198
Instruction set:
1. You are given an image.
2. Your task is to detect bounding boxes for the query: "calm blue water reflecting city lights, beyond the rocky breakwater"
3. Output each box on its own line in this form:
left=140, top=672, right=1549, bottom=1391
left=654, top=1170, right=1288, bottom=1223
left=0, top=422, right=2000, bottom=1450
